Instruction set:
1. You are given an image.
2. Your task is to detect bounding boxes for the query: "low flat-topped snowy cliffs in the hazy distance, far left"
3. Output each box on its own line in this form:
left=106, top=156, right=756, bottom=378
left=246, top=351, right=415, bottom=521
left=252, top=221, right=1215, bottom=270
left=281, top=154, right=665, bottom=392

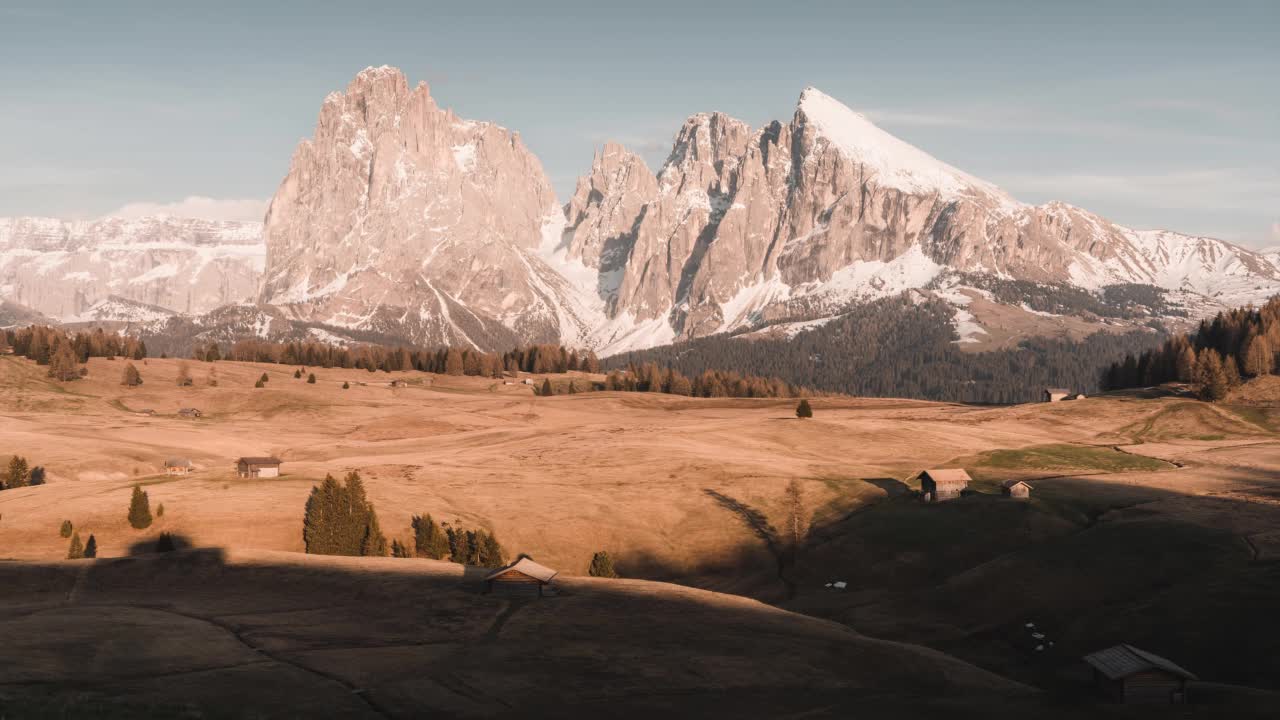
left=0, top=217, right=264, bottom=322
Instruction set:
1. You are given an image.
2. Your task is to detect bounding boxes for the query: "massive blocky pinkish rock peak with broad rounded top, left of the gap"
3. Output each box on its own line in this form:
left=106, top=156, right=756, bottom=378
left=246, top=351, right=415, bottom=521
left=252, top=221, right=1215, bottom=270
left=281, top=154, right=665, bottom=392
left=259, top=67, right=601, bottom=347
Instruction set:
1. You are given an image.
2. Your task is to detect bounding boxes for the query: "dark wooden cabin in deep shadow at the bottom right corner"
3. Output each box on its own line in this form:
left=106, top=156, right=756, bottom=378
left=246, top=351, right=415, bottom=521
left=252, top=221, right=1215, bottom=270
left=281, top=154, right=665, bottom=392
left=1084, top=644, right=1197, bottom=705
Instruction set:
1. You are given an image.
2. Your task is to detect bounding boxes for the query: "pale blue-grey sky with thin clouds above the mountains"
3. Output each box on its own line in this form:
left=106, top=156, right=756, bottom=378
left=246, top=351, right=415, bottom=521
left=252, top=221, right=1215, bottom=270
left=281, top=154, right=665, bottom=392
left=0, top=0, right=1280, bottom=246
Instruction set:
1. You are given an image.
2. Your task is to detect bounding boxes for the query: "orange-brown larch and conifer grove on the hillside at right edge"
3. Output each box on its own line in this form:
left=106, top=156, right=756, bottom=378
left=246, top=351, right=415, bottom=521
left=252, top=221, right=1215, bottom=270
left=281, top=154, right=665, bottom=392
left=1103, top=297, right=1280, bottom=401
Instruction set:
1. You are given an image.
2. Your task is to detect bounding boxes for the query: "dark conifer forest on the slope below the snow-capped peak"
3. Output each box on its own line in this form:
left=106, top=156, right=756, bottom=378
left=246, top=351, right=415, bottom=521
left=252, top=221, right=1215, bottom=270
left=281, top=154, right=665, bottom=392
left=604, top=297, right=1166, bottom=404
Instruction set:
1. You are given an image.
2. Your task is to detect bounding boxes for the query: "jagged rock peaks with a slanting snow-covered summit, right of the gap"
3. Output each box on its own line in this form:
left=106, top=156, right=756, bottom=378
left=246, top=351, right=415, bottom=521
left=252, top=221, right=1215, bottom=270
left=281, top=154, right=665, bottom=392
left=562, top=88, right=1280, bottom=352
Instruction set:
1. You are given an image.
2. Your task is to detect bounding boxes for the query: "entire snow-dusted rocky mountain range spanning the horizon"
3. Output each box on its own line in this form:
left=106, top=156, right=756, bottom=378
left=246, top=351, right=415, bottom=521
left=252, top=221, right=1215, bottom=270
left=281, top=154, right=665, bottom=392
left=0, top=67, right=1280, bottom=355
